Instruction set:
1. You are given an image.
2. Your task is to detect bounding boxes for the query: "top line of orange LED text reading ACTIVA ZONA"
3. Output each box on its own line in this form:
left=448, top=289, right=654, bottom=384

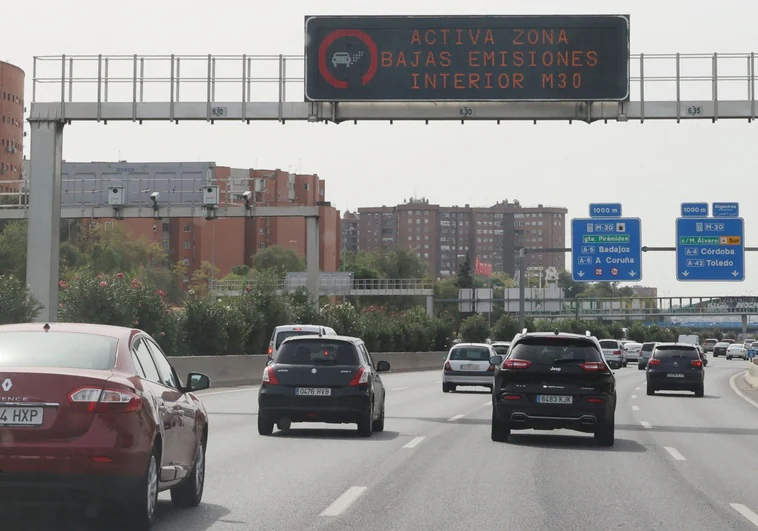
left=411, top=28, right=569, bottom=46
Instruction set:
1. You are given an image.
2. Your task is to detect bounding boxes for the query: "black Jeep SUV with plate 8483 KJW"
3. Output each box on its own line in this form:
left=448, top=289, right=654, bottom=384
left=490, top=331, right=616, bottom=446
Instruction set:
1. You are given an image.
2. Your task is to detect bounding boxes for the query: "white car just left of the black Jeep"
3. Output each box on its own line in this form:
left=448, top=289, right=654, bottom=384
left=442, top=343, right=498, bottom=393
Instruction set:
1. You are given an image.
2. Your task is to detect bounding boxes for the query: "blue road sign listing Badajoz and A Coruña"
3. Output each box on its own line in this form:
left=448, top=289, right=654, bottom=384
left=571, top=218, right=642, bottom=282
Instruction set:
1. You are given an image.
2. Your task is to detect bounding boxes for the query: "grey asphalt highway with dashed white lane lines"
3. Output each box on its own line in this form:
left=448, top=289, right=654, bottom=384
left=3, top=359, right=758, bottom=531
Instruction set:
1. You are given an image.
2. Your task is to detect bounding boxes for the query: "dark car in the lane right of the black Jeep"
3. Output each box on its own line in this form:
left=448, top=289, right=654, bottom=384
left=647, top=343, right=705, bottom=397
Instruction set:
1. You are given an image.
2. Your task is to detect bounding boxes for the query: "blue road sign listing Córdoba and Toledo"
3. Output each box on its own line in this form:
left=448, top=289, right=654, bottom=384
left=676, top=217, right=745, bottom=282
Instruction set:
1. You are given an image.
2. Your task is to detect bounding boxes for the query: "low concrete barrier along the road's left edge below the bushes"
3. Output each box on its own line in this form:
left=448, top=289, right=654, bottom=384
left=169, top=352, right=447, bottom=387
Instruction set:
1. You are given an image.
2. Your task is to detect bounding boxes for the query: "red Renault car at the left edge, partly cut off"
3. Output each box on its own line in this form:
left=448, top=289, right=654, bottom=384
left=0, top=323, right=210, bottom=531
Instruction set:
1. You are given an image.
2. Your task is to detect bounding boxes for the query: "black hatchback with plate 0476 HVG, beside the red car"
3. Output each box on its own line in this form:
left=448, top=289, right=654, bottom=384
left=258, top=335, right=390, bottom=437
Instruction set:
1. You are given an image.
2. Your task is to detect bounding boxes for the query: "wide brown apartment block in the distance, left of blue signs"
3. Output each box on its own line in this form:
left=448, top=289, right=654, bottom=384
left=354, top=198, right=568, bottom=277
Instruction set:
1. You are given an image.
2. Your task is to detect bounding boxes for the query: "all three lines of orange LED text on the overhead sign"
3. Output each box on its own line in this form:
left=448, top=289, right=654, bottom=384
left=380, top=28, right=599, bottom=90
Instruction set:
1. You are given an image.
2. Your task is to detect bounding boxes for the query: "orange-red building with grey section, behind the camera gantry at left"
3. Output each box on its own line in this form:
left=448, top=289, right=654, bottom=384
left=21, top=161, right=340, bottom=281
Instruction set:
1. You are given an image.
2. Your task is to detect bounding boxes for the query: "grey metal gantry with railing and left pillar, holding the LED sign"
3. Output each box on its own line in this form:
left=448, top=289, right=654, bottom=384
left=16, top=53, right=756, bottom=321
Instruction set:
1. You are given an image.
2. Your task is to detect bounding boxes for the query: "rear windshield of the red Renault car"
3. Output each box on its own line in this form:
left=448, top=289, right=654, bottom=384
left=0, top=331, right=118, bottom=370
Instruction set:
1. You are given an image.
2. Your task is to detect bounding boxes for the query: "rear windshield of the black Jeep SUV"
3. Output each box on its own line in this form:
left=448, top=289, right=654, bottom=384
left=508, top=336, right=603, bottom=365
